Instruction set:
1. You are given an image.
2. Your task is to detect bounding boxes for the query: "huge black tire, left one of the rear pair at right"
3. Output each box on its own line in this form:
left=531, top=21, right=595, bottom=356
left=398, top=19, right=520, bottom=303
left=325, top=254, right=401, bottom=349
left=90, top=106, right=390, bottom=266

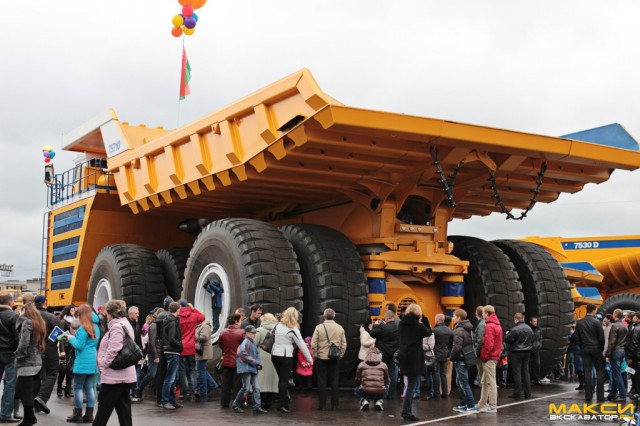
left=449, top=236, right=524, bottom=330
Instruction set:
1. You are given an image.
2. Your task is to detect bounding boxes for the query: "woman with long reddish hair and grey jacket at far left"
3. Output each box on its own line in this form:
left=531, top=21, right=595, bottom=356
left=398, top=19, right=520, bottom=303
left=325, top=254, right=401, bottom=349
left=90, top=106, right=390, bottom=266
left=15, top=303, right=46, bottom=426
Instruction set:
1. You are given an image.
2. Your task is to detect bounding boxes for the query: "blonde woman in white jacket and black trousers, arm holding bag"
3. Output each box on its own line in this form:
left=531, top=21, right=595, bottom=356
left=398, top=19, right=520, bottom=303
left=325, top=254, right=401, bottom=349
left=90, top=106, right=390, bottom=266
left=271, top=307, right=313, bottom=413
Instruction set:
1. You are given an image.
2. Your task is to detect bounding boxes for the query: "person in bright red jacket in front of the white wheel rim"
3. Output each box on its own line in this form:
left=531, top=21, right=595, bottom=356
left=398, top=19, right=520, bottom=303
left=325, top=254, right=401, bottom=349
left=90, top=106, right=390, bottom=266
left=178, top=299, right=204, bottom=399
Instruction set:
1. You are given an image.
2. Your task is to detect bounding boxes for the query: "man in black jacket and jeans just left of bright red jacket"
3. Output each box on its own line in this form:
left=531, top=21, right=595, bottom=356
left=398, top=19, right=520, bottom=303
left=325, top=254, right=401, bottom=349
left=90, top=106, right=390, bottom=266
left=161, top=302, right=182, bottom=410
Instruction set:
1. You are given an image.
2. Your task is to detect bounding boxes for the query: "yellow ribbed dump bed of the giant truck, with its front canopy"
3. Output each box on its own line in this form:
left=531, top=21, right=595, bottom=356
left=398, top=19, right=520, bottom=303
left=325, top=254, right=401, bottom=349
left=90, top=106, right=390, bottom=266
left=65, top=70, right=640, bottom=220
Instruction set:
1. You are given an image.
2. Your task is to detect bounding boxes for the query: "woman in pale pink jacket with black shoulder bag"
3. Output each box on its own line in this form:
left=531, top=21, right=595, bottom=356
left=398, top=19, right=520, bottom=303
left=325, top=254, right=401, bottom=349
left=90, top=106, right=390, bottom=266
left=93, top=300, right=136, bottom=426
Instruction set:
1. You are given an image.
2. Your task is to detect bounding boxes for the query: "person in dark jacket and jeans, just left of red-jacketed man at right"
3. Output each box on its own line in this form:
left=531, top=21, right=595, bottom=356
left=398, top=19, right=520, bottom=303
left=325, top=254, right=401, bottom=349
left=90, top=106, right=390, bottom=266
left=449, top=309, right=478, bottom=412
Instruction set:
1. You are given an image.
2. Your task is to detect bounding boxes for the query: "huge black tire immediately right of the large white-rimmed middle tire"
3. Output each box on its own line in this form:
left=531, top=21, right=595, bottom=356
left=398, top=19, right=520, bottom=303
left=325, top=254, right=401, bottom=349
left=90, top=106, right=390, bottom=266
left=282, top=225, right=369, bottom=378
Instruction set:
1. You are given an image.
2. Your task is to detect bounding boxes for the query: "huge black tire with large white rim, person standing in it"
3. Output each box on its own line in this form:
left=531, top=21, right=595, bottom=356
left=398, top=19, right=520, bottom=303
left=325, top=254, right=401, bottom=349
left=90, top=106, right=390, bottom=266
left=182, top=219, right=302, bottom=342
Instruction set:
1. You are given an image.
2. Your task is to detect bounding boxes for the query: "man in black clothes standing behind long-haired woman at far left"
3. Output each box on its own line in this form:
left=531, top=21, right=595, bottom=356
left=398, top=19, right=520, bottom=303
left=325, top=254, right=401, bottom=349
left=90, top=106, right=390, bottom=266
left=33, top=294, right=60, bottom=414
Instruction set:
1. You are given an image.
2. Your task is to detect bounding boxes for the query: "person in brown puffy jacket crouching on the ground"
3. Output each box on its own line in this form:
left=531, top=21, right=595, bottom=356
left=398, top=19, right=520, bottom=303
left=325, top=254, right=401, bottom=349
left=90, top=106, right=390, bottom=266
left=353, top=346, right=389, bottom=411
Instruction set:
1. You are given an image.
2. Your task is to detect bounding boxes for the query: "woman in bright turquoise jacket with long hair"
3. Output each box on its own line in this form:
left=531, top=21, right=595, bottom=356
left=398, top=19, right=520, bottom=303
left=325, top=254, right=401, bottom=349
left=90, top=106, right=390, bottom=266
left=65, top=304, right=100, bottom=423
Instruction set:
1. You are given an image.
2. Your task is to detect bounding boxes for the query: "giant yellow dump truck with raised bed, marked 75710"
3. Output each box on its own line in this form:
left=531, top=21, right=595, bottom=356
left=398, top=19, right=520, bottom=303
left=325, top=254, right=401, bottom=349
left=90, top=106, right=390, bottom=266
left=47, top=70, right=640, bottom=372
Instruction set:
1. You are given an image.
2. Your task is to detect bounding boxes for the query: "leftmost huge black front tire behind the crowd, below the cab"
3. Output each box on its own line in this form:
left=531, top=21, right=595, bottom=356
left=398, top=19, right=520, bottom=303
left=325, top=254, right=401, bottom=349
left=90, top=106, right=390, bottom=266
left=87, top=244, right=164, bottom=317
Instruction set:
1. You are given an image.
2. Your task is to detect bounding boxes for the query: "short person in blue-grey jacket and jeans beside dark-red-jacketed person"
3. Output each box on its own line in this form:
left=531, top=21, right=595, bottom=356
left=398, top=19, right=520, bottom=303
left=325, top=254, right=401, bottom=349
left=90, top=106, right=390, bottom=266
left=233, top=325, right=267, bottom=414
